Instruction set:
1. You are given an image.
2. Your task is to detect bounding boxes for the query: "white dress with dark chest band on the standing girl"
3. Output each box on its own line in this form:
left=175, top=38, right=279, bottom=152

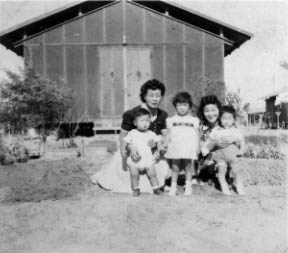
left=165, top=115, right=200, bottom=160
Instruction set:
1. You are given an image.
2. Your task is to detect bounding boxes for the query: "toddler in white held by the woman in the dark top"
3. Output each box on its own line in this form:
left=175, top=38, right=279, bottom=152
left=124, top=108, right=162, bottom=196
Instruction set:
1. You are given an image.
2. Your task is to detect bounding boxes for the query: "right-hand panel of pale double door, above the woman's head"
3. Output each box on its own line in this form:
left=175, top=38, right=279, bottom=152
left=124, top=47, right=151, bottom=109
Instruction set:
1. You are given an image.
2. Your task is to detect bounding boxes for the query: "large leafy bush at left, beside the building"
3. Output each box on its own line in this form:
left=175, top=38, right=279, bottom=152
left=0, top=68, right=72, bottom=132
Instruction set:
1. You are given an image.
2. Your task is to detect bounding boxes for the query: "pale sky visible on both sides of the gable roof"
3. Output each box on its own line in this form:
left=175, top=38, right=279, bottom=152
left=0, top=0, right=288, bottom=105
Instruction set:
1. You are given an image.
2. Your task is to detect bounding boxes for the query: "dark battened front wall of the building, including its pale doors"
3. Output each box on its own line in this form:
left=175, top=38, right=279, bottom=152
left=24, top=2, right=224, bottom=120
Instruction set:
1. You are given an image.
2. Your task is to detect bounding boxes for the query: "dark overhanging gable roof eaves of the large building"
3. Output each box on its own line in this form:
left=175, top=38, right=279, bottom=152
left=0, top=0, right=253, bottom=56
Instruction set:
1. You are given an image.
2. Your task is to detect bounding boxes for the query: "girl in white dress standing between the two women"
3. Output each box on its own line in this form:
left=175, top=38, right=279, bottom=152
left=164, top=92, right=199, bottom=196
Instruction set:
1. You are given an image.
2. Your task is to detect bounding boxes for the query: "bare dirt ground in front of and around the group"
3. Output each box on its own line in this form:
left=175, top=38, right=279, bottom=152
left=0, top=134, right=288, bottom=253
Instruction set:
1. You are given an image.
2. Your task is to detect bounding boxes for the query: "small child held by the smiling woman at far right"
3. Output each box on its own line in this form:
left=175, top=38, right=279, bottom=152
left=201, top=106, right=245, bottom=195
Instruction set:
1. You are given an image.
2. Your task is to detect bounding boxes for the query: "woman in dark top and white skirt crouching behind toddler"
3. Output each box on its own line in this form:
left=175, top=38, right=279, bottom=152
left=93, top=79, right=169, bottom=192
